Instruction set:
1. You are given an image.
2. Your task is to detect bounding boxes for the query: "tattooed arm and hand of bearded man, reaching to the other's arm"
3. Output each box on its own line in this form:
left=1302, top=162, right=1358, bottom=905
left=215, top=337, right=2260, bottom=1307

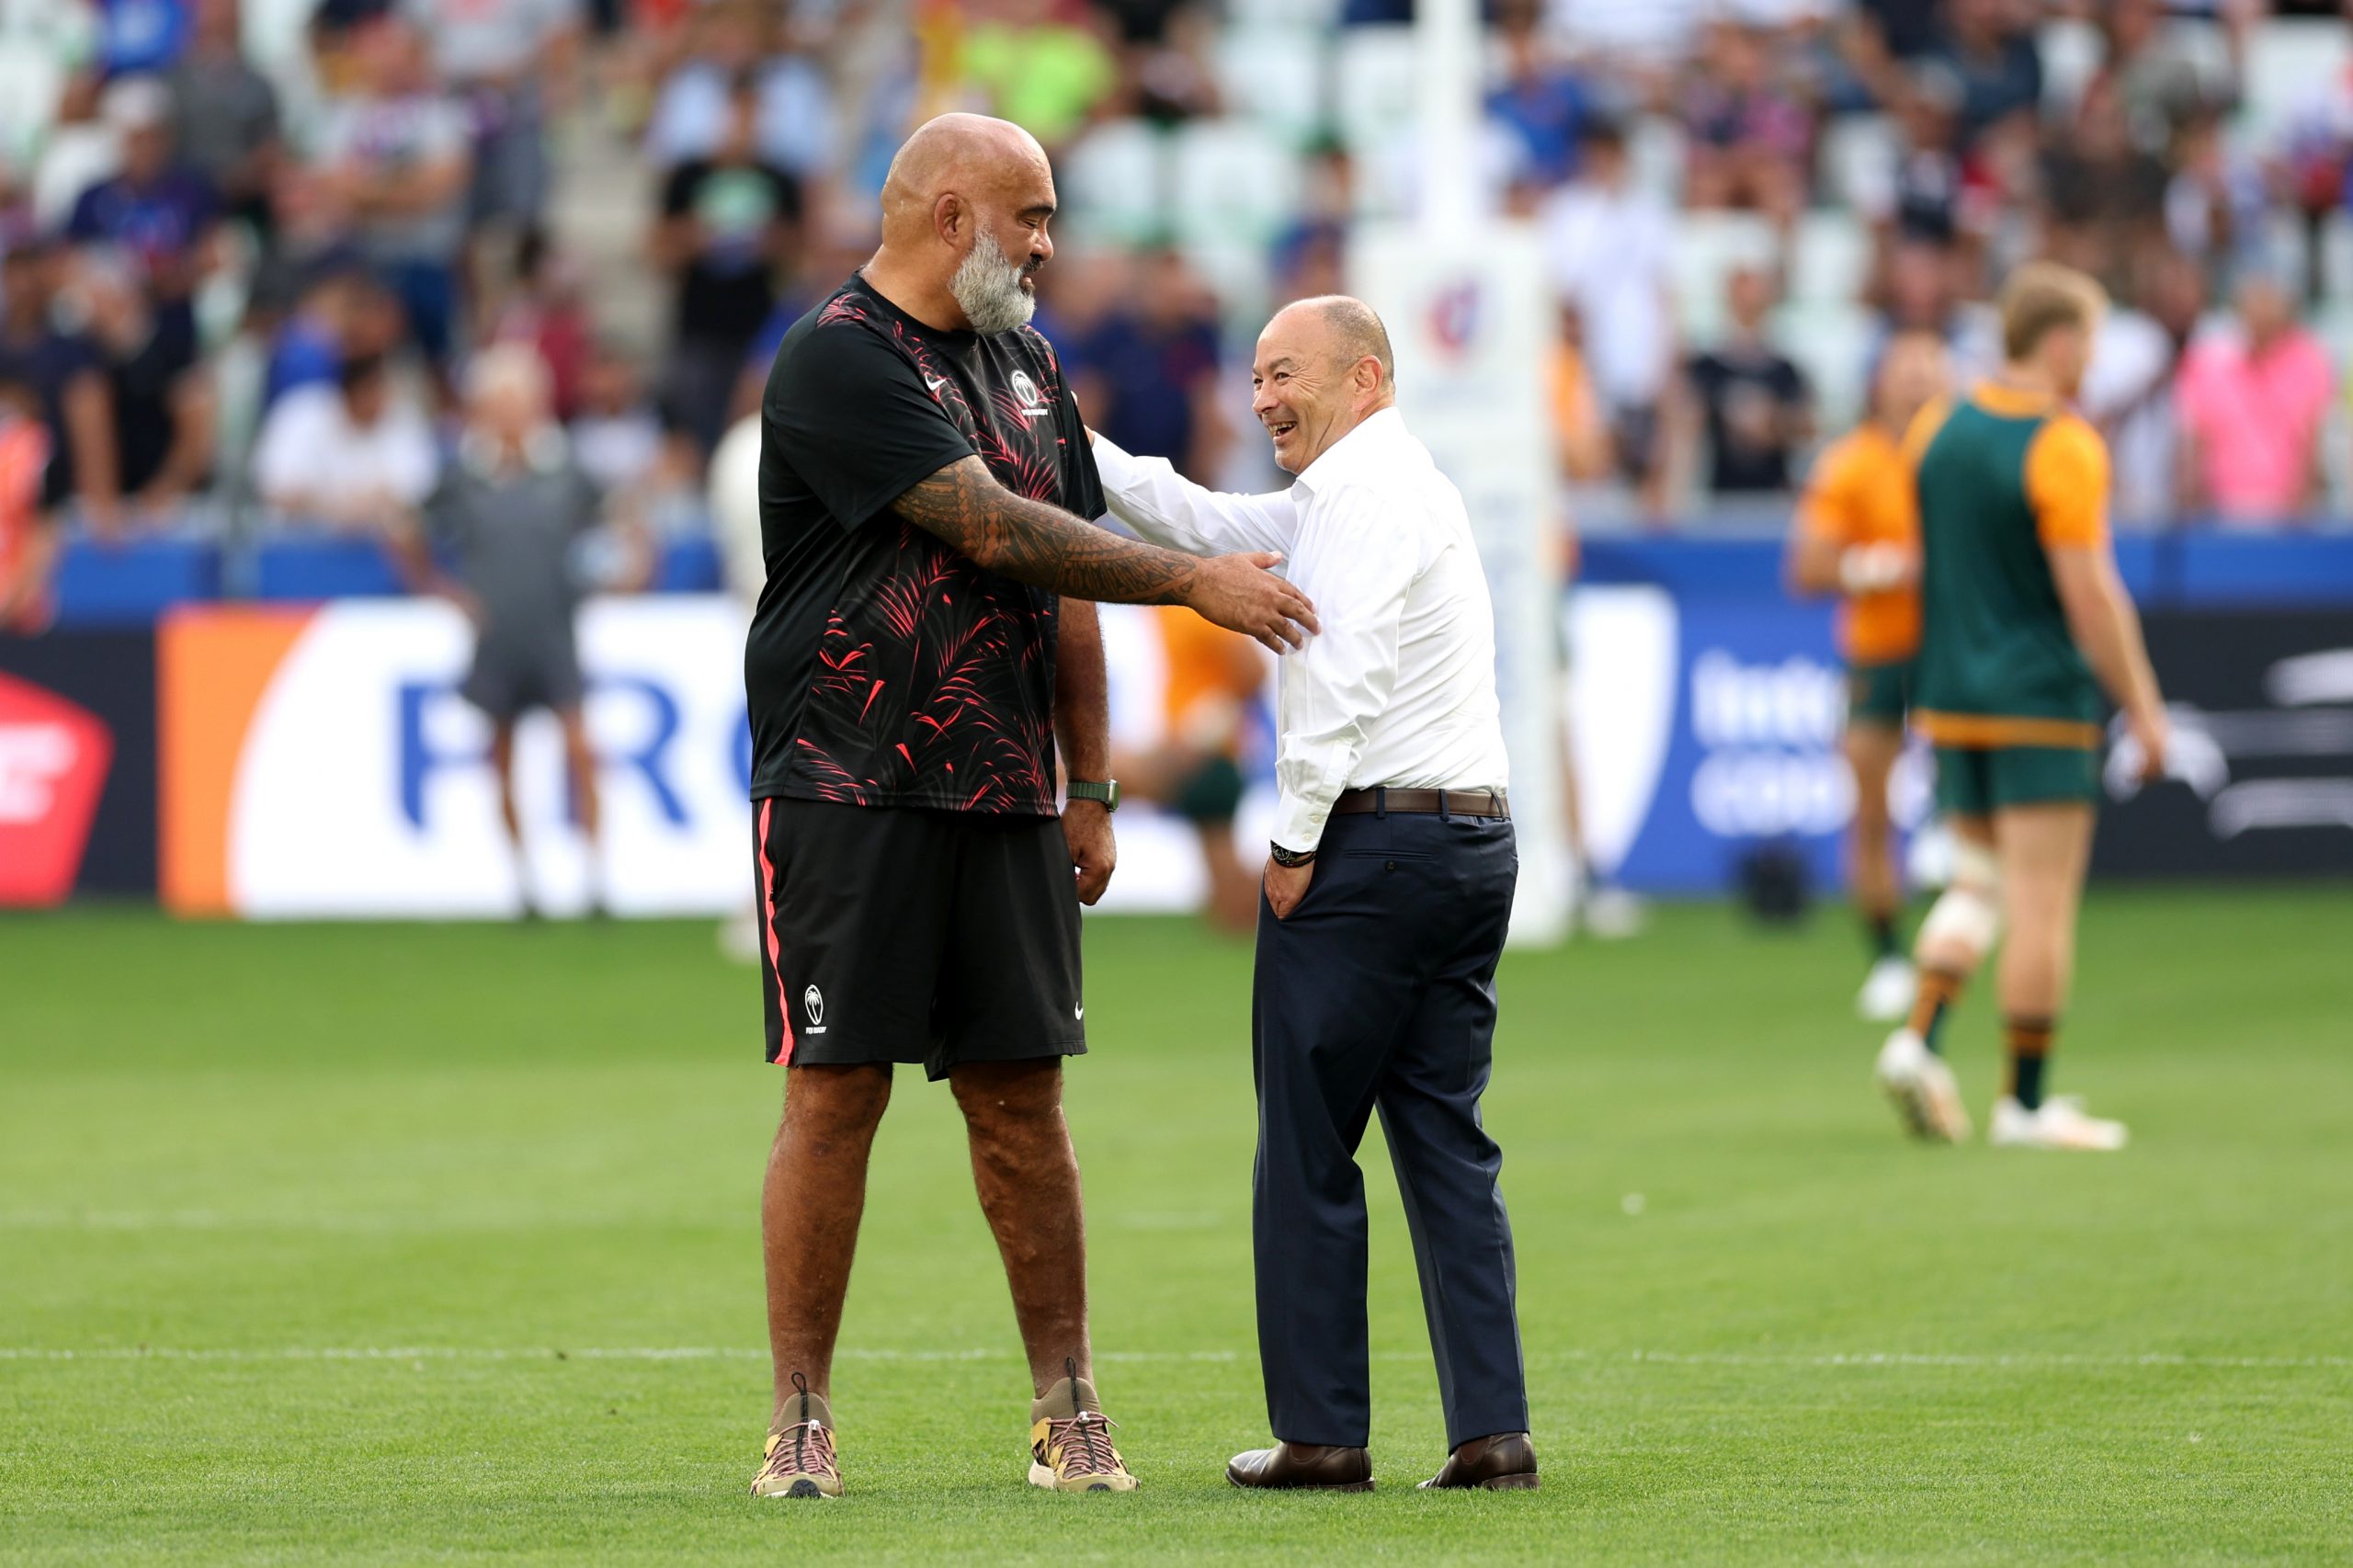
left=892, top=457, right=1315, bottom=653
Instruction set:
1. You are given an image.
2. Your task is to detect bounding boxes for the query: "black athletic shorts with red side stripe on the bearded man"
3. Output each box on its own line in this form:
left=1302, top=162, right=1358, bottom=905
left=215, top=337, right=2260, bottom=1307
left=753, top=798, right=1087, bottom=1081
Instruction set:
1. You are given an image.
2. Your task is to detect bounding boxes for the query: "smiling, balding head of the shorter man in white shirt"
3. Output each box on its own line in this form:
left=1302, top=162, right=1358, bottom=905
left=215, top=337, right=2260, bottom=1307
left=1249, top=294, right=1398, bottom=473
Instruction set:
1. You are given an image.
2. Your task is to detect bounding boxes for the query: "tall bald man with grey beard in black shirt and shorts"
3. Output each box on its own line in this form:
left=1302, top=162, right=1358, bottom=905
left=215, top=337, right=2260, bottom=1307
left=744, top=116, right=1315, bottom=1497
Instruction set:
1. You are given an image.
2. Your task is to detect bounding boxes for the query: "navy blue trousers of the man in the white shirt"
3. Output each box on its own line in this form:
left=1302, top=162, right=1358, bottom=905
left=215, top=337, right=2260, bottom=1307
left=1252, top=812, right=1527, bottom=1448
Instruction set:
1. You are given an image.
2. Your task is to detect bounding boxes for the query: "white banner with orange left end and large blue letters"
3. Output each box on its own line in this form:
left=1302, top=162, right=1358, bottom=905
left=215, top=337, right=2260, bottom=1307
left=158, top=596, right=1202, bottom=918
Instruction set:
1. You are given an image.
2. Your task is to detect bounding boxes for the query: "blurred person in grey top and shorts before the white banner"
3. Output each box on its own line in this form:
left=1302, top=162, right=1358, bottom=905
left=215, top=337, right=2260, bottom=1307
left=400, top=344, right=652, bottom=909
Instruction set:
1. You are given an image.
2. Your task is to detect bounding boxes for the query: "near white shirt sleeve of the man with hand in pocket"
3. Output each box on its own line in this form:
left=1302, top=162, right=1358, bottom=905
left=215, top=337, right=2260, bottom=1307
left=1273, top=485, right=1421, bottom=852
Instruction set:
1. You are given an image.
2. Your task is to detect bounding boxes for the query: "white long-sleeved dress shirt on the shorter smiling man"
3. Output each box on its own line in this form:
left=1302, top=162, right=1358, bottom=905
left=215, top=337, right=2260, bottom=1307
left=1094, top=407, right=1506, bottom=852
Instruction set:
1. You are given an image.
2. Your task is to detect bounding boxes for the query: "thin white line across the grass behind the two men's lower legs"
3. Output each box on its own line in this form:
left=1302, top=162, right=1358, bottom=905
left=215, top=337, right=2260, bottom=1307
left=0, top=1345, right=2353, bottom=1370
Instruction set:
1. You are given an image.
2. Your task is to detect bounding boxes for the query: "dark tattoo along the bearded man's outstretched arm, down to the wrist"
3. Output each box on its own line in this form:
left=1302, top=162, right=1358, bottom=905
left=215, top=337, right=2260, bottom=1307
left=892, top=457, right=1200, bottom=605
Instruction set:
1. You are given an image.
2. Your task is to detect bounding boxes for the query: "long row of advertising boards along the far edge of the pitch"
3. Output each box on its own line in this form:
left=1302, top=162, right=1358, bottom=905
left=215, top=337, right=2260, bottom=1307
left=0, top=534, right=2353, bottom=918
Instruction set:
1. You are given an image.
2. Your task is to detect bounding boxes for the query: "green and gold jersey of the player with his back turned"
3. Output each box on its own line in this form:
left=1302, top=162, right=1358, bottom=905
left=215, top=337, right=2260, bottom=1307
left=1906, top=381, right=2109, bottom=746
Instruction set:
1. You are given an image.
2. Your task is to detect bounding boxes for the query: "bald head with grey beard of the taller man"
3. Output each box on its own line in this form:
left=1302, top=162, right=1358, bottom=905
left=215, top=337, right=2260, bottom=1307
left=866, top=116, right=1054, bottom=332
